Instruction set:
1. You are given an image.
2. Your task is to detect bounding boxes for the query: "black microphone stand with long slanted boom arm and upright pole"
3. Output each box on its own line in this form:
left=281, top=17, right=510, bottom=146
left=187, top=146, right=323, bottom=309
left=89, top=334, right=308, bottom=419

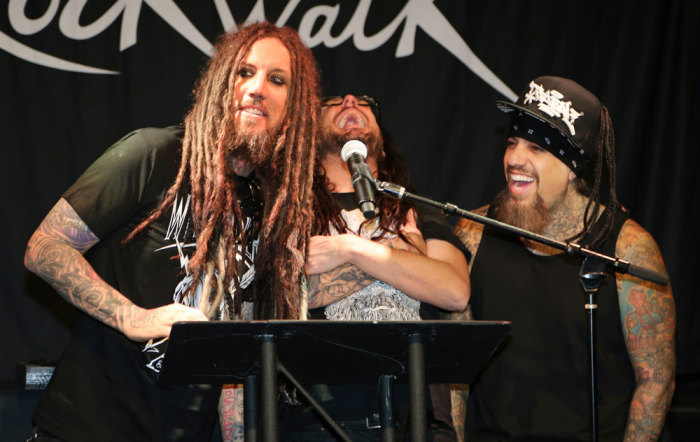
left=368, top=177, right=668, bottom=442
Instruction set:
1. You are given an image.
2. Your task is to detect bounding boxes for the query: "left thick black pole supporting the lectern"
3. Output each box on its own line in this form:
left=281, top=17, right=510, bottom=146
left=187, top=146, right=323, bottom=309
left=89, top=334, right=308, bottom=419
left=260, top=335, right=279, bottom=441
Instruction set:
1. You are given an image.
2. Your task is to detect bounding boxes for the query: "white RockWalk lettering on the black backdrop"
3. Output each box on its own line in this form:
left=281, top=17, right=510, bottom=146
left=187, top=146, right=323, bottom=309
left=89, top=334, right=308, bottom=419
left=0, top=0, right=517, bottom=101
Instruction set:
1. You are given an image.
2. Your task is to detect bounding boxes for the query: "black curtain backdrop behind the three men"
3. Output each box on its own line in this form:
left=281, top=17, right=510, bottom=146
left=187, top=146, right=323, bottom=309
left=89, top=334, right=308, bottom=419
left=0, top=0, right=700, bottom=404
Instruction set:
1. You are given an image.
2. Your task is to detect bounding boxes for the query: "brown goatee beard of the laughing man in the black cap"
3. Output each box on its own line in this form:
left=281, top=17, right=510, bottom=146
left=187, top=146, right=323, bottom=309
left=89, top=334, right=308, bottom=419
left=492, top=188, right=552, bottom=235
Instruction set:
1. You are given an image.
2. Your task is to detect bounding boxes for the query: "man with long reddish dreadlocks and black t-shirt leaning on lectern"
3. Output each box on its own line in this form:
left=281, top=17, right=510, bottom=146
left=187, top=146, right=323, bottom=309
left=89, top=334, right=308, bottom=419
left=25, top=23, right=319, bottom=441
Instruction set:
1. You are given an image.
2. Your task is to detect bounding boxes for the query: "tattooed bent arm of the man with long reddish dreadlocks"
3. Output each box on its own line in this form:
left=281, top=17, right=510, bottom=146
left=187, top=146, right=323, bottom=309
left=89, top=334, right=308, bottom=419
left=25, top=199, right=130, bottom=328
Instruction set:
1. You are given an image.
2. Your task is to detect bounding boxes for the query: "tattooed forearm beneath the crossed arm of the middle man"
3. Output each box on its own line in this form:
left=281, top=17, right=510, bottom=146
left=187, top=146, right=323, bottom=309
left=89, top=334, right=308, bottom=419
left=309, top=264, right=376, bottom=308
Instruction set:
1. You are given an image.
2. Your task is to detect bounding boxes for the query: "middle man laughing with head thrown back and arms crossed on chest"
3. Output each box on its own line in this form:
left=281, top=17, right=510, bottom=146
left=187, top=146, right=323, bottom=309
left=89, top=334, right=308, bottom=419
left=284, top=95, right=469, bottom=440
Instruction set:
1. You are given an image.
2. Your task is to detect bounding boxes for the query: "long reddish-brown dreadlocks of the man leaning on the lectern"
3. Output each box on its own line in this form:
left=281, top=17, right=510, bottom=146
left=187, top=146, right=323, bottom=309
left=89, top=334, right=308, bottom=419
left=125, top=22, right=320, bottom=319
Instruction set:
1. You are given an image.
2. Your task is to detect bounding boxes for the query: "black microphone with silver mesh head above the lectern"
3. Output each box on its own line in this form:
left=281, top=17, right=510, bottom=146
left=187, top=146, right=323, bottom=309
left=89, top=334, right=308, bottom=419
left=340, top=140, right=377, bottom=219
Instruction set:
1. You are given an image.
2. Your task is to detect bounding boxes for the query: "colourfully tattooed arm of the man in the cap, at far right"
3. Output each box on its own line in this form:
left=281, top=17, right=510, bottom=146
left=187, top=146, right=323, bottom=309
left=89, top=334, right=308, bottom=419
left=616, top=221, right=676, bottom=441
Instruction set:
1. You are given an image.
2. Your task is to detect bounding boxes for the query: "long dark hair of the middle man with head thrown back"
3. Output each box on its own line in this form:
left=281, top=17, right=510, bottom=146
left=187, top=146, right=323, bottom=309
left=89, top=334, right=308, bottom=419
left=313, top=128, right=414, bottom=244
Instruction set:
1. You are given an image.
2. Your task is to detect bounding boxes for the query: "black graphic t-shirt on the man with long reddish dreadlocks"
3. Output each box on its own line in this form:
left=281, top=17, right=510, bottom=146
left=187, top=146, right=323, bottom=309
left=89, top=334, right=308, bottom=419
left=35, top=127, right=254, bottom=441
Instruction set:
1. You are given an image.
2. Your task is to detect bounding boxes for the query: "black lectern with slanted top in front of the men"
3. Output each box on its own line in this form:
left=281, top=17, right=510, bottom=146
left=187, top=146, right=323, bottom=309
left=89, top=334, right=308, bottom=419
left=159, top=320, right=511, bottom=441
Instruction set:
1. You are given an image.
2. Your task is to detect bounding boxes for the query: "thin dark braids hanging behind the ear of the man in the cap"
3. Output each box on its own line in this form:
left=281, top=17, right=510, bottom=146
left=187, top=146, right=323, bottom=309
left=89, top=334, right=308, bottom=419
left=569, top=105, right=621, bottom=249
